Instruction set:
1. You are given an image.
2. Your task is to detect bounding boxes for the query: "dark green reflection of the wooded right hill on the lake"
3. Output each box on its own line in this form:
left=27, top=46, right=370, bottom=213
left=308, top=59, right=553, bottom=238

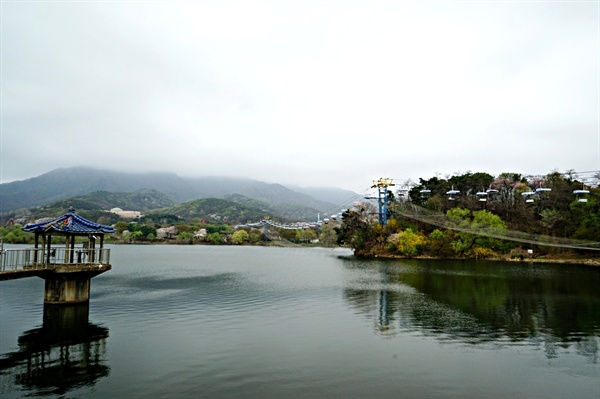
left=344, top=259, right=600, bottom=363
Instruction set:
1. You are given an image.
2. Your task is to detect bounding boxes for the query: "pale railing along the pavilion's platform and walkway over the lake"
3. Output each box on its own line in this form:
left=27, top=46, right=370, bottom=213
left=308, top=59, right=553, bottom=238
left=0, top=247, right=110, bottom=272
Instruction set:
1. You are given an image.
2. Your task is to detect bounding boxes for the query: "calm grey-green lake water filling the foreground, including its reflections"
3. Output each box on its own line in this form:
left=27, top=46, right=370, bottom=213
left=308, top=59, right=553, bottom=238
left=0, top=245, right=600, bottom=399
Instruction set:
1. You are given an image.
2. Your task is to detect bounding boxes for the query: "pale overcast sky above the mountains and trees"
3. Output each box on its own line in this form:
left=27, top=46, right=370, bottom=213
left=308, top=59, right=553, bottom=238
left=0, top=0, right=600, bottom=192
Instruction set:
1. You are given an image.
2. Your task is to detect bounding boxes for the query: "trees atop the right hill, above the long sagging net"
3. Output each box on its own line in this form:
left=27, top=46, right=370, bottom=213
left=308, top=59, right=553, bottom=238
left=410, top=172, right=600, bottom=237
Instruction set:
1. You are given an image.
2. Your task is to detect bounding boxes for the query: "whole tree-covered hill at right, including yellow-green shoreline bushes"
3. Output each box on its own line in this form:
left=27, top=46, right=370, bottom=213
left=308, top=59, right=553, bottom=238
left=338, top=172, right=600, bottom=259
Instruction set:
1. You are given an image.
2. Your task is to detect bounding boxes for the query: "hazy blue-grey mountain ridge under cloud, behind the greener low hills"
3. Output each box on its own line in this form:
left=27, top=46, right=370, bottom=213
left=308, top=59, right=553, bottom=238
left=0, top=167, right=356, bottom=220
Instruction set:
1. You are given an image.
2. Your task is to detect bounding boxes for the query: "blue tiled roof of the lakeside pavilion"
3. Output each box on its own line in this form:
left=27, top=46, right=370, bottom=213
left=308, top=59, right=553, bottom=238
left=23, top=208, right=116, bottom=234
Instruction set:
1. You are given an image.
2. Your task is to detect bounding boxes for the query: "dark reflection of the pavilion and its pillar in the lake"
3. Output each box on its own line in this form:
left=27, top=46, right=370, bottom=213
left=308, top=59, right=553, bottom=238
left=0, top=304, right=110, bottom=395
